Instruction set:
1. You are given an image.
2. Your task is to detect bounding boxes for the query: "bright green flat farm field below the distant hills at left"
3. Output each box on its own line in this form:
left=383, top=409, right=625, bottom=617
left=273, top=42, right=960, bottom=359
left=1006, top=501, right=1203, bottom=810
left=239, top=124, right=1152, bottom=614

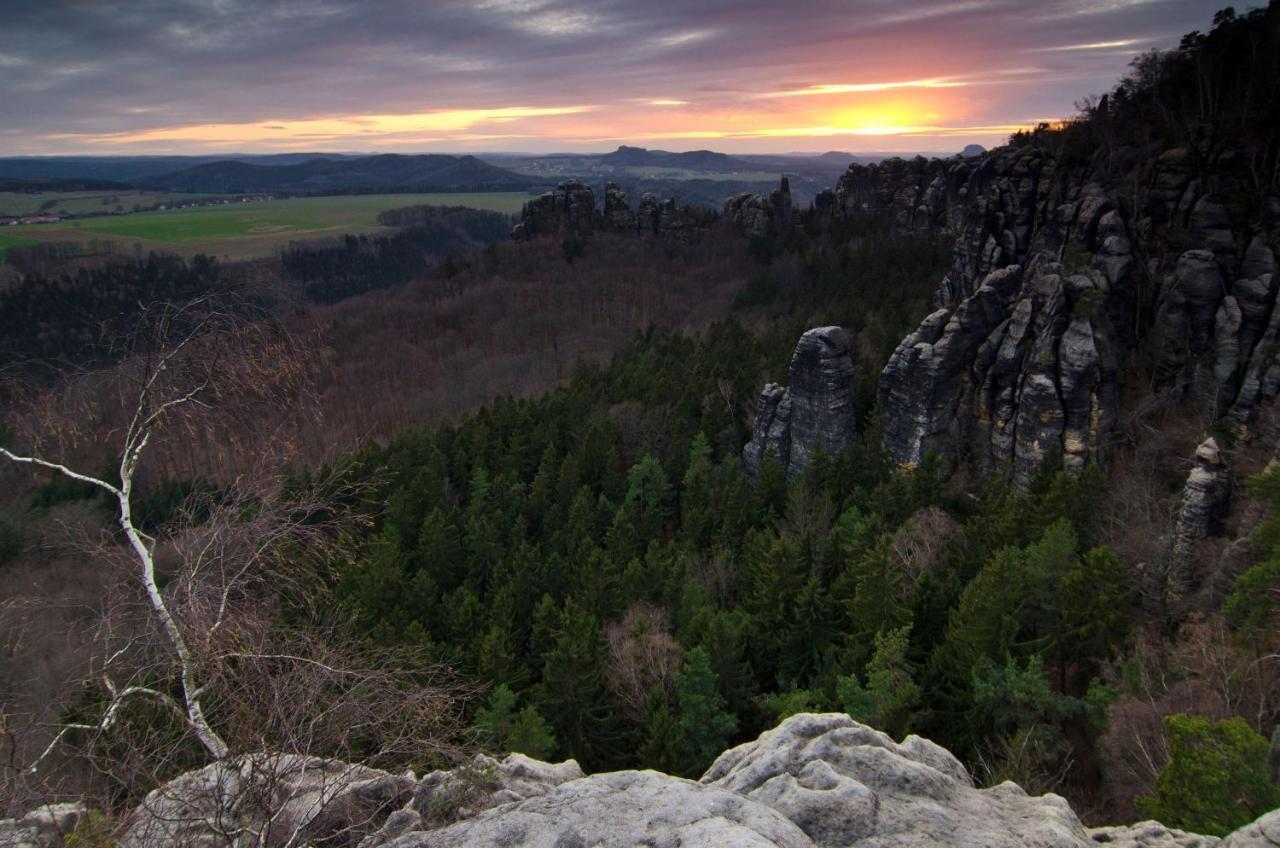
left=0, top=192, right=529, bottom=259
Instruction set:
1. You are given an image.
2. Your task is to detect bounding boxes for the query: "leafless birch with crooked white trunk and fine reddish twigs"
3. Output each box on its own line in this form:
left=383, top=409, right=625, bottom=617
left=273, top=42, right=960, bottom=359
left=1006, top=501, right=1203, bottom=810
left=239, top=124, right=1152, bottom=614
left=0, top=301, right=462, bottom=847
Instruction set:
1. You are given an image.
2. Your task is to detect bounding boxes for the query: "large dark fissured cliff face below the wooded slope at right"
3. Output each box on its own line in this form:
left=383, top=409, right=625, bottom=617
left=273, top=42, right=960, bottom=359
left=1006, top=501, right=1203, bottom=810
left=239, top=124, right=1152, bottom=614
left=839, top=137, right=1280, bottom=533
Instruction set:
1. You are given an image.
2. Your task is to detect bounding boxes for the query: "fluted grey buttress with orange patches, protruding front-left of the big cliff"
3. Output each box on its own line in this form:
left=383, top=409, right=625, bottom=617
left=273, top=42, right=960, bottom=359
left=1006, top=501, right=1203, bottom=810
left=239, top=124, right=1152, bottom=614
left=879, top=265, right=1116, bottom=483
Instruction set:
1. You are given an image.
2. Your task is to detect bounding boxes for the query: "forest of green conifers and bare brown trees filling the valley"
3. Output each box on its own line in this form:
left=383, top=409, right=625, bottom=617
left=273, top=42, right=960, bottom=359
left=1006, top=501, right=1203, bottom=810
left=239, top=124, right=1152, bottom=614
left=0, top=4, right=1280, bottom=834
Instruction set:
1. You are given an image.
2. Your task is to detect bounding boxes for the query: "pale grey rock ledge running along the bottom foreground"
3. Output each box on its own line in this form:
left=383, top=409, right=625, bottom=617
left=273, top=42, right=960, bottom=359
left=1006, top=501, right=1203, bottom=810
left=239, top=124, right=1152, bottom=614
left=12, top=713, right=1280, bottom=848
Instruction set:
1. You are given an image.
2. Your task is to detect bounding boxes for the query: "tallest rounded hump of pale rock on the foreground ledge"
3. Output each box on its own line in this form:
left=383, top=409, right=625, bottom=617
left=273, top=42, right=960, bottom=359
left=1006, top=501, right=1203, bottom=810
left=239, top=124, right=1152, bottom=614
left=701, top=713, right=1089, bottom=848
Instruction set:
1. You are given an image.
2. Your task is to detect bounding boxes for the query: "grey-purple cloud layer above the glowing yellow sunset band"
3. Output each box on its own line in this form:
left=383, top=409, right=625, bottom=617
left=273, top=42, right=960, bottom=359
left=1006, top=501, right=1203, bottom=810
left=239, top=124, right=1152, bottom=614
left=0, top=0, right=1224, bottom=152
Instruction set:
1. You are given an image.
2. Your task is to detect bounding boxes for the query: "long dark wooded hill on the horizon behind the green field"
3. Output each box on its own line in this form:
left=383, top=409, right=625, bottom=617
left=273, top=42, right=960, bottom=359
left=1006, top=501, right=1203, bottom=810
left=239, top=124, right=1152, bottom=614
left=138, top=154, right=534, bottom=193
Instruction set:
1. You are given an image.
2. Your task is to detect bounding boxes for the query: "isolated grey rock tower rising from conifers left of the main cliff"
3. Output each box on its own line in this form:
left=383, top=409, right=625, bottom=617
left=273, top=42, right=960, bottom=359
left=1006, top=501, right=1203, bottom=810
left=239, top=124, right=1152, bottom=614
left=742, top=327, right=858, bottom=477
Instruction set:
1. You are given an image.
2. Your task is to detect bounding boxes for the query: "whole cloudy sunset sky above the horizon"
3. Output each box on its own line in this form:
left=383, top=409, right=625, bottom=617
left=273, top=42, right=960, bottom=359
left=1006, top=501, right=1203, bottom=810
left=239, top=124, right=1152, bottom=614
left=0, top=0, right=1226, bottom=155
